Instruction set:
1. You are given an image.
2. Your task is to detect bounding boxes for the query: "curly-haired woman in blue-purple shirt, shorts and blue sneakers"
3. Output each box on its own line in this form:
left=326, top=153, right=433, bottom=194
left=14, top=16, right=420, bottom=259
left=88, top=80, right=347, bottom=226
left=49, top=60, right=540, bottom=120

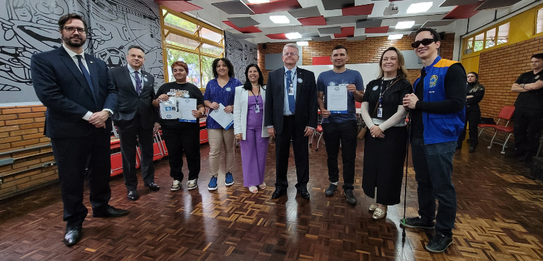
left=204, top=58, right=242, bottom=190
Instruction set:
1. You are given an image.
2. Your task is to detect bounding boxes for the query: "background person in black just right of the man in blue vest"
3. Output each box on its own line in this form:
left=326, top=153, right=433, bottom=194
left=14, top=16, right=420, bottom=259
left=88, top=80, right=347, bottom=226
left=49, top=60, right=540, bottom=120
left=456, top=72, right=485, bottom=153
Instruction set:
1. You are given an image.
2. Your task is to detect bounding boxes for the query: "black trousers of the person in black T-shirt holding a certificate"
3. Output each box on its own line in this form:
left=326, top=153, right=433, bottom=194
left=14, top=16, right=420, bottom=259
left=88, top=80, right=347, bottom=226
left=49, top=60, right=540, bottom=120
left=162, top=123, right=200, bottom=181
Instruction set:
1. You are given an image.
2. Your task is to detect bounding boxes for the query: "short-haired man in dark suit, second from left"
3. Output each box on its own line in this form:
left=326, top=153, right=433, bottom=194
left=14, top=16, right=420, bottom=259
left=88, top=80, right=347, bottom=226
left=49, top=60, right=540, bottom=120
left=109, top=46, right=160, bottom=200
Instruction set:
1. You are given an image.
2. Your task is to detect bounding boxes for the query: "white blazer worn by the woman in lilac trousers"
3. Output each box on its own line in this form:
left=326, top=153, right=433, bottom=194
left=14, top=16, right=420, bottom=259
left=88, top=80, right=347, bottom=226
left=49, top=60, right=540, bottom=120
left=234, top=85, right=270, bottom=140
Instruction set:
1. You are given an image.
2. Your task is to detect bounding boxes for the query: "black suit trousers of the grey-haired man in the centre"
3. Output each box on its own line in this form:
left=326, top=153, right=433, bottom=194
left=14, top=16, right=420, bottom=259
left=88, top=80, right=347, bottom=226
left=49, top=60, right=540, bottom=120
left=275, top=116, right=309, bottom=190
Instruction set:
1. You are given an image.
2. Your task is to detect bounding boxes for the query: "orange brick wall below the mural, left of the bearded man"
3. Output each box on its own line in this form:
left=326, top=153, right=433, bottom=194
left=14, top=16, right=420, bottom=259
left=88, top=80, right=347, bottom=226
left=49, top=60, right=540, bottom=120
left=0, top=105, right=58, bottom=199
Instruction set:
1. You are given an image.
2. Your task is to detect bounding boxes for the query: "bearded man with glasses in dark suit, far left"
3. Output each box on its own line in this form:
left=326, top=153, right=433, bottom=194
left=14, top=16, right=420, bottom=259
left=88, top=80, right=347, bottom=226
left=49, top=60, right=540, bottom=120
left=30, top=14, right=128, bottom=246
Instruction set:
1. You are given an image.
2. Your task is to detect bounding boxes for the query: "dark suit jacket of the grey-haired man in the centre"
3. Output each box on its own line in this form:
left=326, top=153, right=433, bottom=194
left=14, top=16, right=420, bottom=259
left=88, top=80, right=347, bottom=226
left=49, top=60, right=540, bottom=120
left=265, top=67, right=317, bottom=136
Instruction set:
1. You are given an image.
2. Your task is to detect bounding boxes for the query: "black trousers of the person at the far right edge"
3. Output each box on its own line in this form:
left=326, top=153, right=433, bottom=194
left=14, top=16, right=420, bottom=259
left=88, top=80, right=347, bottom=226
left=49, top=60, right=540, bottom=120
left=513, top=107, right=543, bottom=158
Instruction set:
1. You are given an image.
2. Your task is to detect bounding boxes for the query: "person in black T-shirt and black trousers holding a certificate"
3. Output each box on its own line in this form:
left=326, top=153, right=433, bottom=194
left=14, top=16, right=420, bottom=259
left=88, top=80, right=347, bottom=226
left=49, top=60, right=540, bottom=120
left=153, top=61, right=205, bottom=191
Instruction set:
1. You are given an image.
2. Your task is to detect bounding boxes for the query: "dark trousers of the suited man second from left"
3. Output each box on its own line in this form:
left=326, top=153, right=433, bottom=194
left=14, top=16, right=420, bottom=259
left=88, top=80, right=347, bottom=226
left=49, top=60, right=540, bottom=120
left=117, top=116, right=155, bottom=191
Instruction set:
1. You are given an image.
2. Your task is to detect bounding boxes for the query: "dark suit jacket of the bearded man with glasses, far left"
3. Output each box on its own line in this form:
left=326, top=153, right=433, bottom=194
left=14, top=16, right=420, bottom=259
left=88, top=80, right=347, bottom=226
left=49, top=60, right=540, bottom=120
left=30, top=47, right=117, bottom=138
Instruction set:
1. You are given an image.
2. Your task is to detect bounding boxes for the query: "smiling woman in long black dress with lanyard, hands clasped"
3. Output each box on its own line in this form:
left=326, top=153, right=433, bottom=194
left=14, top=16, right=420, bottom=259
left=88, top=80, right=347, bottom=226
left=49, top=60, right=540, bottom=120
left=362, top=47, right=413, bottom=219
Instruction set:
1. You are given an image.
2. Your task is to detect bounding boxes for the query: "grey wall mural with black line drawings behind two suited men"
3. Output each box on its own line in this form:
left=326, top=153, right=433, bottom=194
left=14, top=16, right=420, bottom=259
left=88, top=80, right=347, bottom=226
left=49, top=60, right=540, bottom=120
left=0, top=0, right=164, bottom=103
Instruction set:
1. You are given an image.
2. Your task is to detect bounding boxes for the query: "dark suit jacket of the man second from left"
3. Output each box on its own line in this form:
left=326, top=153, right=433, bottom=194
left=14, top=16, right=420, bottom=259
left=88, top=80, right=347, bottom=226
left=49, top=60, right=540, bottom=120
left=109, top=65, right=155, bottom=129
